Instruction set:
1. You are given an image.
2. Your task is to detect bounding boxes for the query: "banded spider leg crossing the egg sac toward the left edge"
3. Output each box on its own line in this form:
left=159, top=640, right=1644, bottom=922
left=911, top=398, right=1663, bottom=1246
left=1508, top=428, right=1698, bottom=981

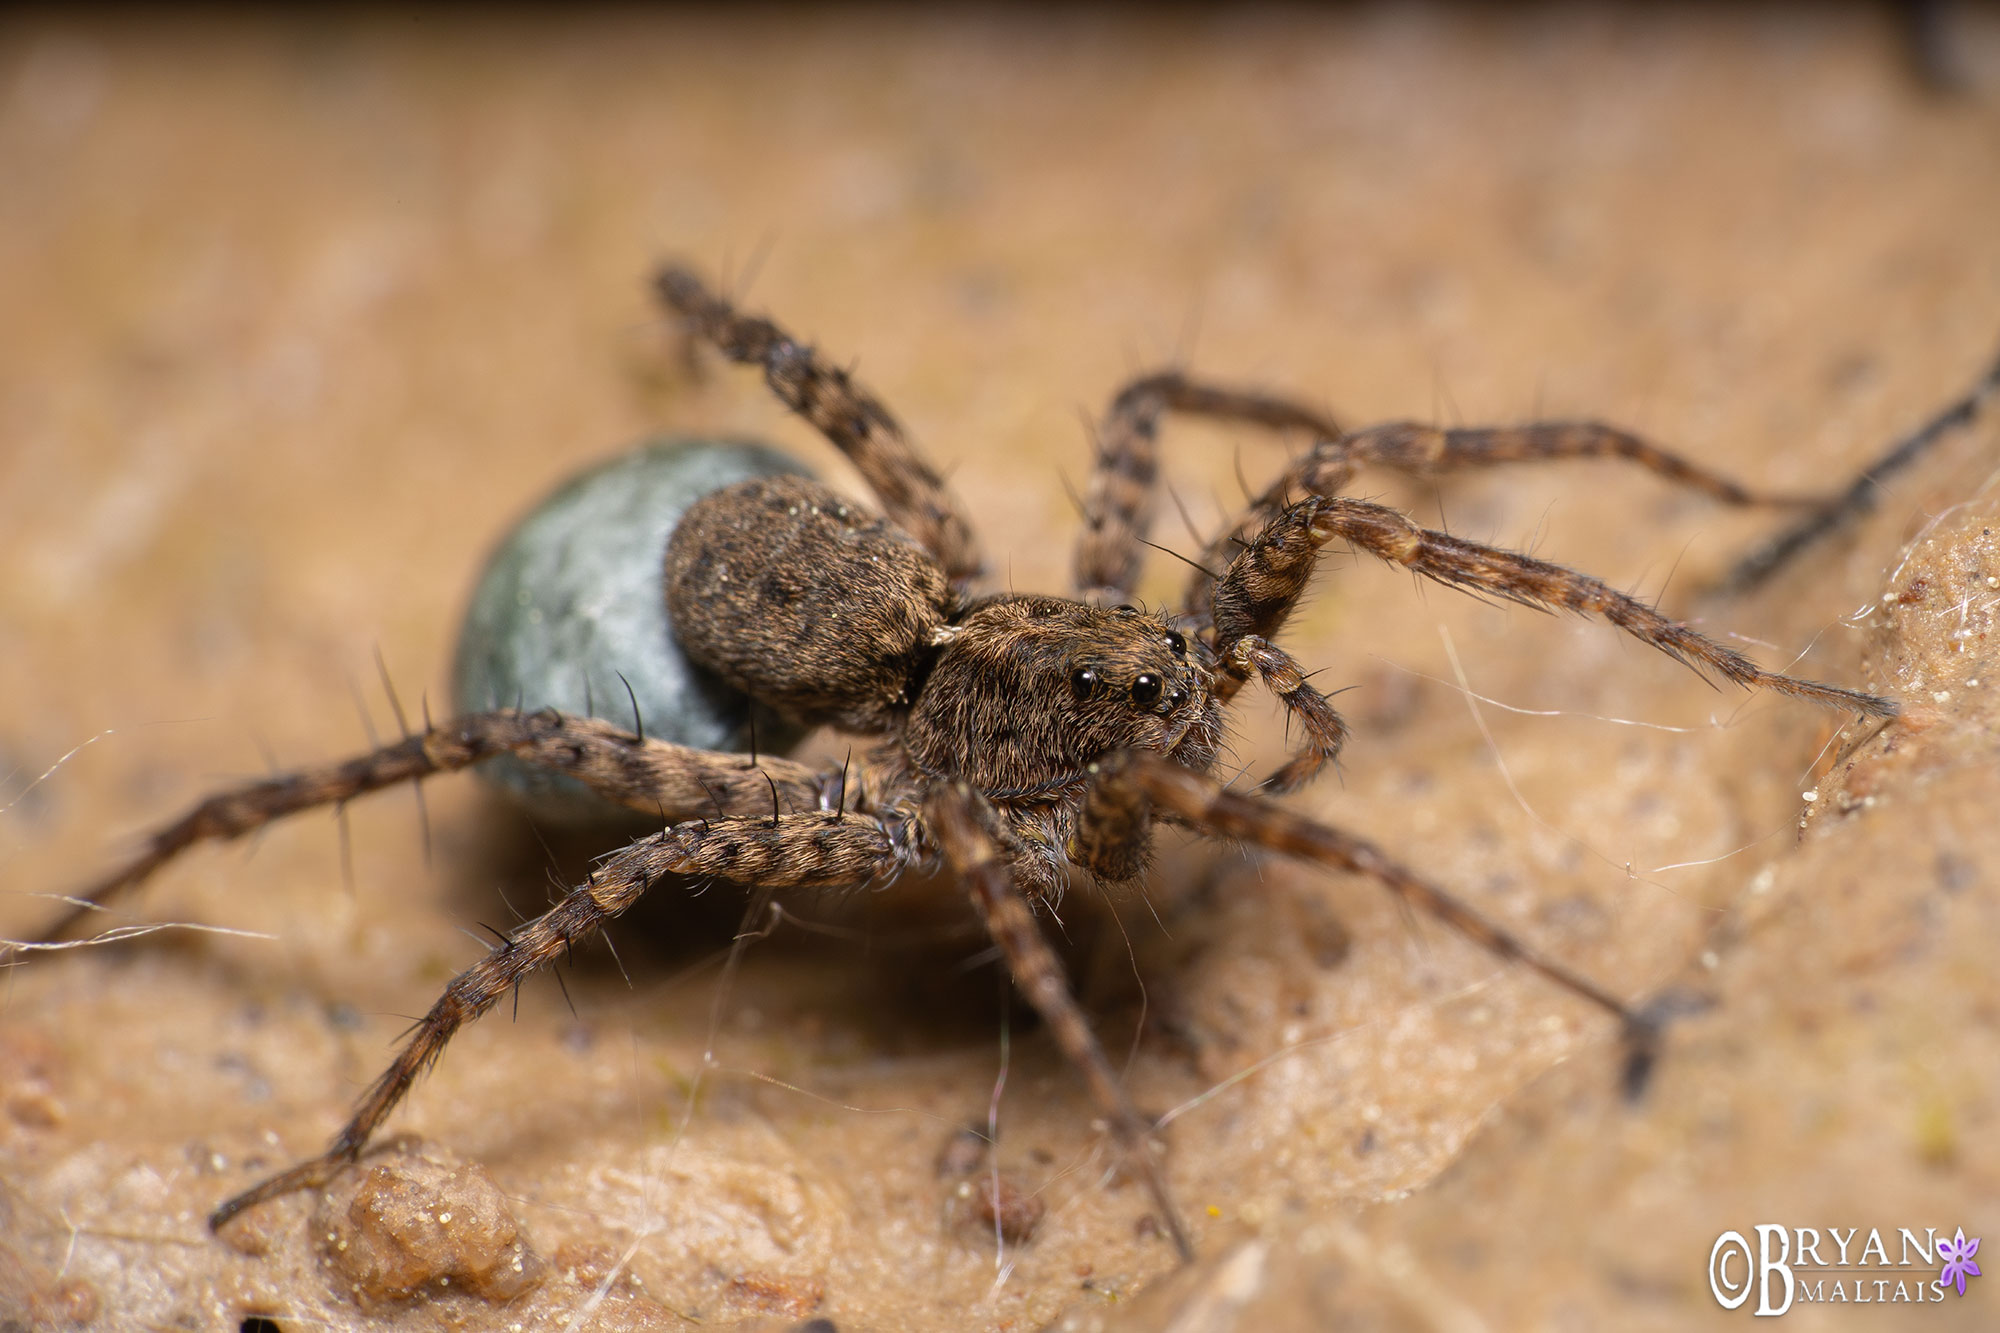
left=40, top=709, right=836, bottom=941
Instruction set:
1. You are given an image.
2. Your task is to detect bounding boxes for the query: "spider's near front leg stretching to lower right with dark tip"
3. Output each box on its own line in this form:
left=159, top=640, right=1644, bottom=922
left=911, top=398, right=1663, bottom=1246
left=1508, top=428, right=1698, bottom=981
left=1072, top=751, right=1658, bottom=1095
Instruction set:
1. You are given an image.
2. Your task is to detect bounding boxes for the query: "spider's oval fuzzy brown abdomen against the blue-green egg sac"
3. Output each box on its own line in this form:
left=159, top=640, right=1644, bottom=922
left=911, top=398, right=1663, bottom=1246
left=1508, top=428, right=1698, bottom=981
left=666, top=476, right=954, bottom=733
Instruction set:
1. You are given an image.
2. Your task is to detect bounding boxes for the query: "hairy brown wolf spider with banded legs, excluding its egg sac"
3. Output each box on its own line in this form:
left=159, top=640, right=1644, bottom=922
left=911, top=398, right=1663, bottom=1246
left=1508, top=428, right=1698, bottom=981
left=39, top=266, right=1898, bottom=1257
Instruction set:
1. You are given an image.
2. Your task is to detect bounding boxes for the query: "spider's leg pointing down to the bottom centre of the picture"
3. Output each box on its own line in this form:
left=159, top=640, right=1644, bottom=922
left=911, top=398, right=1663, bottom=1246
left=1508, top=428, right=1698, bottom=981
left=924, top=783, right=1194, bottom=1259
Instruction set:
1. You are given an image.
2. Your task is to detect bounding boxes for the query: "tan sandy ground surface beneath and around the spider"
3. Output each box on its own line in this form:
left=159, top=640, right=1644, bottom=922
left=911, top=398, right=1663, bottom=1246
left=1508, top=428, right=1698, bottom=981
left=0, top=10, right=2000, bottom=1333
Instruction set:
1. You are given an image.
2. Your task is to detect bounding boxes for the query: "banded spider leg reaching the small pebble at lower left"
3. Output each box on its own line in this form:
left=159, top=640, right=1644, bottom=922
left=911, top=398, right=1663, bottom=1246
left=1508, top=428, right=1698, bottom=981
left=208, top=813, right=910, bottom=1231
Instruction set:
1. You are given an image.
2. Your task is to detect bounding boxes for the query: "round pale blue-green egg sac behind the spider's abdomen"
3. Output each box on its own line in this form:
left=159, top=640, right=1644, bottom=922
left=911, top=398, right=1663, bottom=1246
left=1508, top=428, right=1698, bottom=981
left=452, top=438, right=808, bottom=827
